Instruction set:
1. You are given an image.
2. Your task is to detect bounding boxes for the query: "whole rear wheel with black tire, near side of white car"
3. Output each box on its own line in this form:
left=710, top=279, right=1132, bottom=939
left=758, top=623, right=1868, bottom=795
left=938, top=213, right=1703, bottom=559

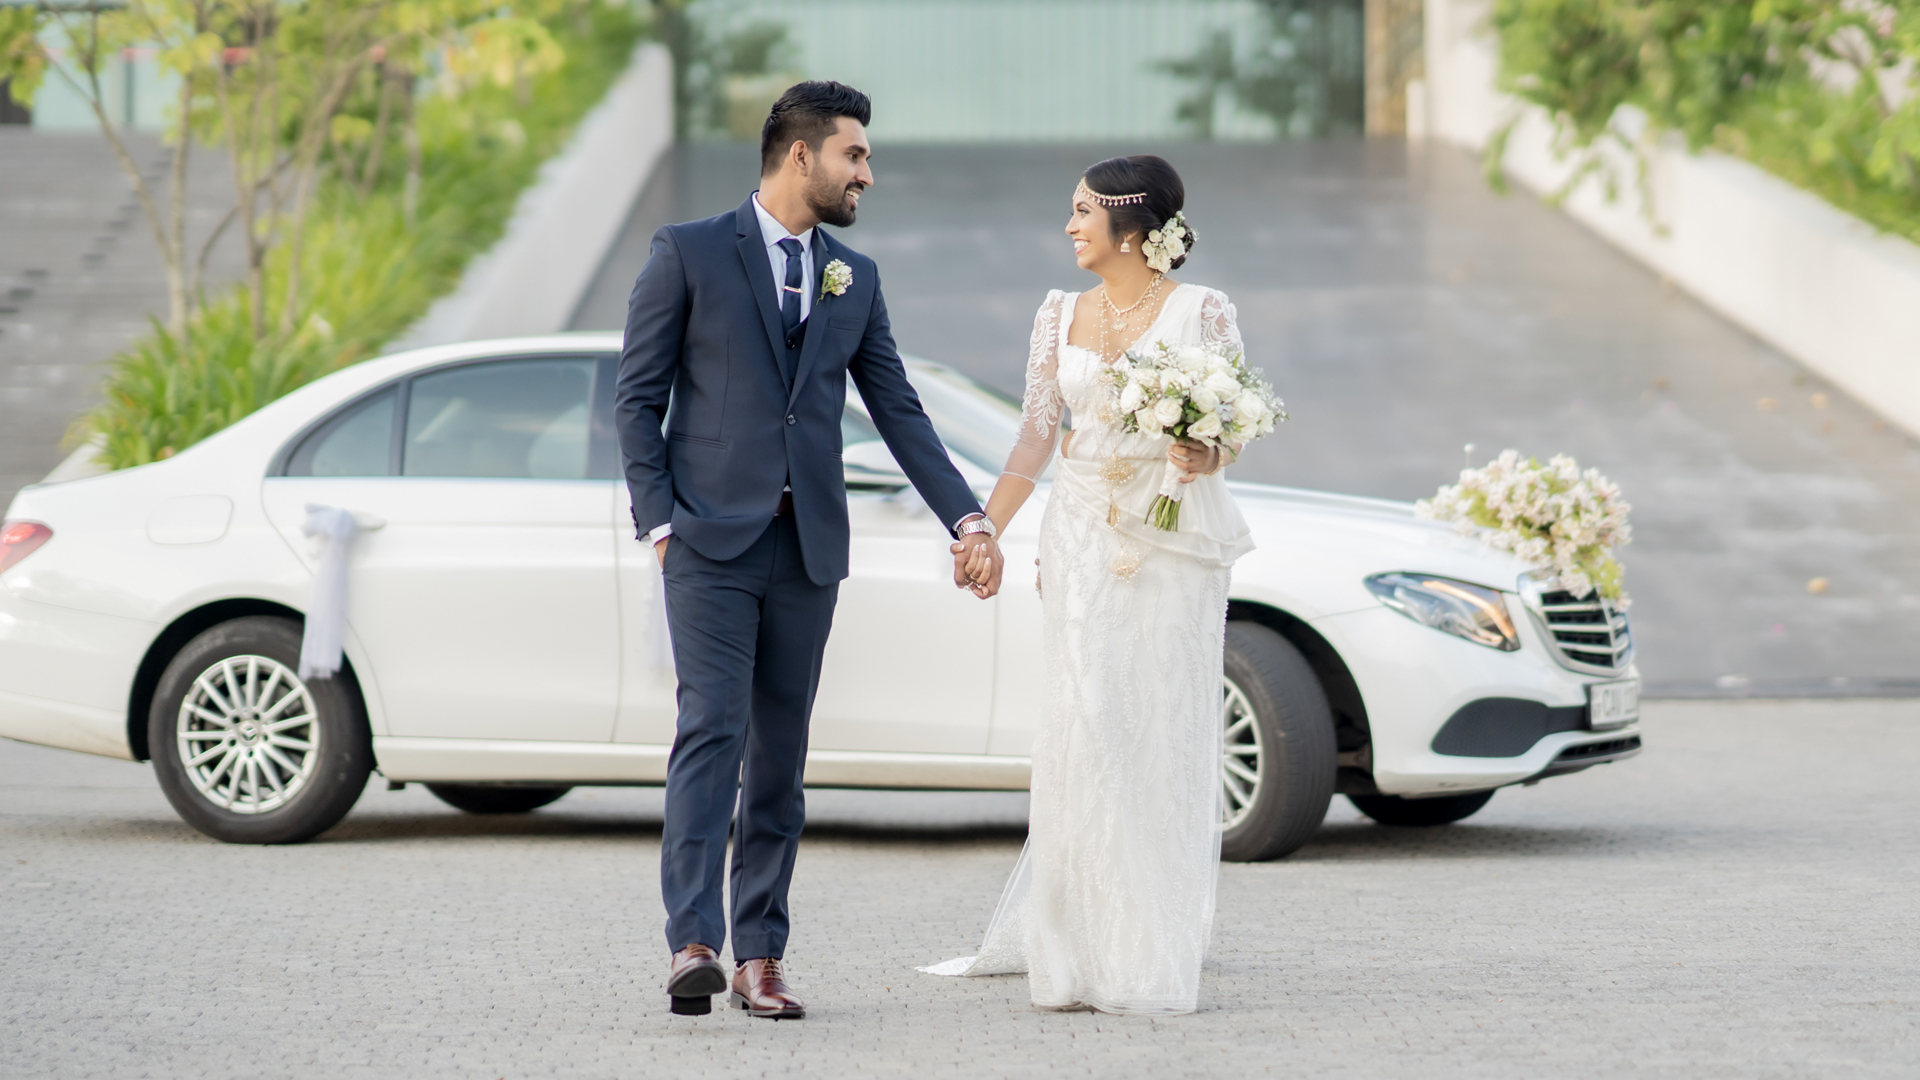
left=148, top=615, right=372, bottom=844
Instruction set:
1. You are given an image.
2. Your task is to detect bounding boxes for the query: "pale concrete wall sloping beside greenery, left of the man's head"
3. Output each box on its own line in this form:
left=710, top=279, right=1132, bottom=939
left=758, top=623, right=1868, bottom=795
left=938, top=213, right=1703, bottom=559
left=388, top=42, right=674, bottom=352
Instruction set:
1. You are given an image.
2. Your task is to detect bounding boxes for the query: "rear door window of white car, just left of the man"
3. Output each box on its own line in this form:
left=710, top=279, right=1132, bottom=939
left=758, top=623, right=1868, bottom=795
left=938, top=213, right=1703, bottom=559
left=401, top=357, right=599, bottom=480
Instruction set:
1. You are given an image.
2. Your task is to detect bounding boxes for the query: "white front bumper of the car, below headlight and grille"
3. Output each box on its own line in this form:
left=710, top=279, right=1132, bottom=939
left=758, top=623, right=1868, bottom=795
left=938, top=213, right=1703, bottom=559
left=1313, top=607, right=1640, bottom=796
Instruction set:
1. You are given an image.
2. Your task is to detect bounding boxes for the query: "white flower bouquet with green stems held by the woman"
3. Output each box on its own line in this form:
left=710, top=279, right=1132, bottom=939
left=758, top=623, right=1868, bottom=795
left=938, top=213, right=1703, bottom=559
left=1106, top=342, right=1286, bottom=532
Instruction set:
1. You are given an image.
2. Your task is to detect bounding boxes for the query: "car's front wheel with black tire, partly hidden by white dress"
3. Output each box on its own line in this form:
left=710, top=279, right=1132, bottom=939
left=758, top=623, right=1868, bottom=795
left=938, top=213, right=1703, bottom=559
left=1219, top=623, right=1338, bottom=863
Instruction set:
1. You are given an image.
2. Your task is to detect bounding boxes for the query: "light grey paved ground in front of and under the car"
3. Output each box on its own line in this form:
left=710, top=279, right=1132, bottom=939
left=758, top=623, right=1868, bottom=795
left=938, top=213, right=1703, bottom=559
left=0, top=701, right=1920, bottom=1080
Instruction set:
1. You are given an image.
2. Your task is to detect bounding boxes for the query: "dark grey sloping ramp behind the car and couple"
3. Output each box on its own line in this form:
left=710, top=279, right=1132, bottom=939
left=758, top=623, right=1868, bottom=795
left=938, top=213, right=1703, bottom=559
left=576, top=140, right=1920, bottom=698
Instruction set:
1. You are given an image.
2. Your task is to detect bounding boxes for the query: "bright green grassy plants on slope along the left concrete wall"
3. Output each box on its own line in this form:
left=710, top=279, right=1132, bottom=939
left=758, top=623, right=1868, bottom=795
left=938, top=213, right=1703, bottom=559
left=83, top=2, right=641, bottom=469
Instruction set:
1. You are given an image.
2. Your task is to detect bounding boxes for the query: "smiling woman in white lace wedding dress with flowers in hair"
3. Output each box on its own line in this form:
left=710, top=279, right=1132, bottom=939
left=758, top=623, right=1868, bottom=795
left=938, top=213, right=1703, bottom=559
left=922, top=156, right=1254, bottom=1013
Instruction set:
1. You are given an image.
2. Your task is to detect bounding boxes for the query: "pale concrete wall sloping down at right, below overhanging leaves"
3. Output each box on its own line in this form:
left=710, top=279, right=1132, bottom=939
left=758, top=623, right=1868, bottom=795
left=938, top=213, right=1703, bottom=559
left=1409, top=0, right=1920, bottom=434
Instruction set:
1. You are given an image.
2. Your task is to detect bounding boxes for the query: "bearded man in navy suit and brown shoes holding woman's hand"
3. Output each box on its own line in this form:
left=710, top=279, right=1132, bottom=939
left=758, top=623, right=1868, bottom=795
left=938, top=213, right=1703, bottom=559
left=614, top=83, right=1000, bottom=1019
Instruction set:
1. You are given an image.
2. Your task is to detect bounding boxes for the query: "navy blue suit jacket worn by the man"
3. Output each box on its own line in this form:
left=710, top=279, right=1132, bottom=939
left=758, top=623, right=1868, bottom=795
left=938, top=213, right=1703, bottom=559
left=614, top=198, right=979, bottom=584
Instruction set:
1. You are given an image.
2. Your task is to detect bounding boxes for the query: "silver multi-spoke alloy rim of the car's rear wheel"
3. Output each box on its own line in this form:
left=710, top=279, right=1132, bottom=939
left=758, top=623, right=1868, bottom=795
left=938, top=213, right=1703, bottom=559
left=175, top=655, right=323, bottom=813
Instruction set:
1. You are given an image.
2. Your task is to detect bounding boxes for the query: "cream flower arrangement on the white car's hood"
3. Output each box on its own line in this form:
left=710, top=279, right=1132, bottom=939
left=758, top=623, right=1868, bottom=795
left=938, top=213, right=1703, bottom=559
left=1413, top=450, right=1634, bottom=595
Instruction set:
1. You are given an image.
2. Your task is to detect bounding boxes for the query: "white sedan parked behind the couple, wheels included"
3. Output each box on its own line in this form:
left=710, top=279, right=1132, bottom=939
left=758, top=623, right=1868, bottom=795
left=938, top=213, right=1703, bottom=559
left=0, top=334, right=1640, bottom=859
